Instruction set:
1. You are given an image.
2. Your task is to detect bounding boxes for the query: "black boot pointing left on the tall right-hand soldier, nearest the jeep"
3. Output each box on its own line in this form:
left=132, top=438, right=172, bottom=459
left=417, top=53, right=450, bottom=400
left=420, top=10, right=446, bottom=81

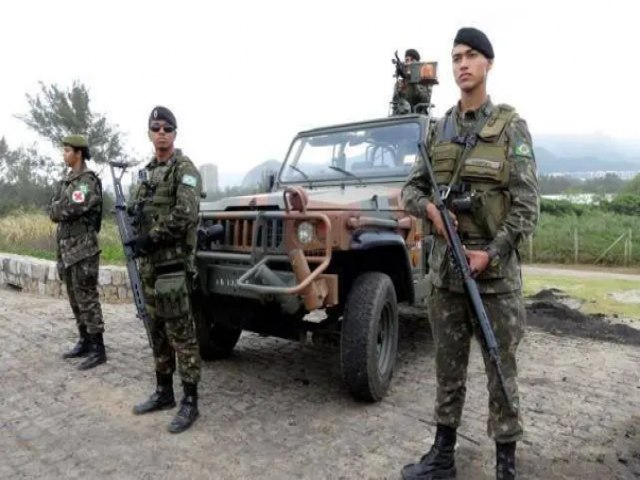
left=401, top=424, right=456, bottom=480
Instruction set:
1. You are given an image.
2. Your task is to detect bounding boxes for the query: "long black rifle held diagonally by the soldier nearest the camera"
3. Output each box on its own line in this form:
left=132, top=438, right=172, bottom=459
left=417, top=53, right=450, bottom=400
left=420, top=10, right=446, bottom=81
left=418, top=142, right=513, bottom=409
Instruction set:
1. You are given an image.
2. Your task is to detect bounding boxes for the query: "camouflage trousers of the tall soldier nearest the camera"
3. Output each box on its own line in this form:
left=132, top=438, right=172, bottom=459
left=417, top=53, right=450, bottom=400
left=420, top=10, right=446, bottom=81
left=429, top=288, right=526, bottom=443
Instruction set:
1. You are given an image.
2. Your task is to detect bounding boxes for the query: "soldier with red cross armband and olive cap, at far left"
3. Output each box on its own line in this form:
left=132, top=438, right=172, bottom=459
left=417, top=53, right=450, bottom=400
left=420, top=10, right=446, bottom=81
left=49, top=135, right=107, bottom=370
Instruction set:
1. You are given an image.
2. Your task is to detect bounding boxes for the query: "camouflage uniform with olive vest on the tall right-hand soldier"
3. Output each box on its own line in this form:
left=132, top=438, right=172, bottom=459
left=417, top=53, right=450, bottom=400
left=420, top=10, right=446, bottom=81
left=402, top=100, right=539, bottom=443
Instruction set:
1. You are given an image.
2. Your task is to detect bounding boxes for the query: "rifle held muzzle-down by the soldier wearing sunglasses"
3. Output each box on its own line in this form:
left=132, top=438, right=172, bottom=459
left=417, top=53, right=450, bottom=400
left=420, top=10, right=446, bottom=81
left=109, top=162, right=153, bottom=349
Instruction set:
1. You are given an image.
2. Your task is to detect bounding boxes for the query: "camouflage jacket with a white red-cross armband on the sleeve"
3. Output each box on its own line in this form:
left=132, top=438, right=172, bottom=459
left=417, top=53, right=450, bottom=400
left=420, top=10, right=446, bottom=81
left=49, top=166, right=102, bottom=267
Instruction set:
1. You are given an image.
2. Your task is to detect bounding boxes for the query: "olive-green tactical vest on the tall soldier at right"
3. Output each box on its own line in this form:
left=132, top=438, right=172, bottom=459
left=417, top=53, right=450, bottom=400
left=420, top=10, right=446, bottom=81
left=432, top=104, right=516, bottom=242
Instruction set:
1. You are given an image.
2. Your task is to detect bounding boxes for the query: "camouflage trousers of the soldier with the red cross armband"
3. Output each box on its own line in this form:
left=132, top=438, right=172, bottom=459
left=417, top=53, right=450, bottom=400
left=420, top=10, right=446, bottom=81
left=58, top=255, right=104, bottom=334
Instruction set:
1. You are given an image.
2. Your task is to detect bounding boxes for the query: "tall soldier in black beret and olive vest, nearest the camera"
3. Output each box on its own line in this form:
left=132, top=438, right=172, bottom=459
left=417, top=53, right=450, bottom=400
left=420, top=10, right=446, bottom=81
left=402, top=28, right=539, bottom=479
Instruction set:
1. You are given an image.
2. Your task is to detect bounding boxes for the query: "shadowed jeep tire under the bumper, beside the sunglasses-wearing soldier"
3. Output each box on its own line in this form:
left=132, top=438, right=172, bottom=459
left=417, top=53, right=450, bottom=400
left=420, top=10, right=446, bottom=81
left=194, top=296, right=242, bottom=360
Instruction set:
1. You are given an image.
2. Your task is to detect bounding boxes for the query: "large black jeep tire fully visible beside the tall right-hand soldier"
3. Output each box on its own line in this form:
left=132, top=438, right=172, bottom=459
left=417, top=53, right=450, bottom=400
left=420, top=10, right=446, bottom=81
left=340, top=272, right=398, bottom=402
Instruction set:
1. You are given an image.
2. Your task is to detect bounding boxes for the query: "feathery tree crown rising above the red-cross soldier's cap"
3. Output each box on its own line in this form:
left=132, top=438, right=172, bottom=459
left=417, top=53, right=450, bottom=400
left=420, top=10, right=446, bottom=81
left=18, top=81, right=124, bottom=163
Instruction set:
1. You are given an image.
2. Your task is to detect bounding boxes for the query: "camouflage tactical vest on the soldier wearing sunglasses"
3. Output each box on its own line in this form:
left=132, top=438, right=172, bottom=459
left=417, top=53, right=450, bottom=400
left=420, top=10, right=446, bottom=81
left=136, top=152, right=197, bottom=265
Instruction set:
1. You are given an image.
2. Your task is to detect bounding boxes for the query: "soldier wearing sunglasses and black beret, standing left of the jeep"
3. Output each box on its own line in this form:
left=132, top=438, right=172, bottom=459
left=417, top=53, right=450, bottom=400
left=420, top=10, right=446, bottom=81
left=129, top=106, right=202, bottom=433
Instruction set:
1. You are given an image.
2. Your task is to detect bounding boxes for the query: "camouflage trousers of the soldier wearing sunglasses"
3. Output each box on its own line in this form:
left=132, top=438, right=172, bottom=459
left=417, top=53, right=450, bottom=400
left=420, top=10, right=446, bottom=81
left=140, top=263, right=201, bottom=383
